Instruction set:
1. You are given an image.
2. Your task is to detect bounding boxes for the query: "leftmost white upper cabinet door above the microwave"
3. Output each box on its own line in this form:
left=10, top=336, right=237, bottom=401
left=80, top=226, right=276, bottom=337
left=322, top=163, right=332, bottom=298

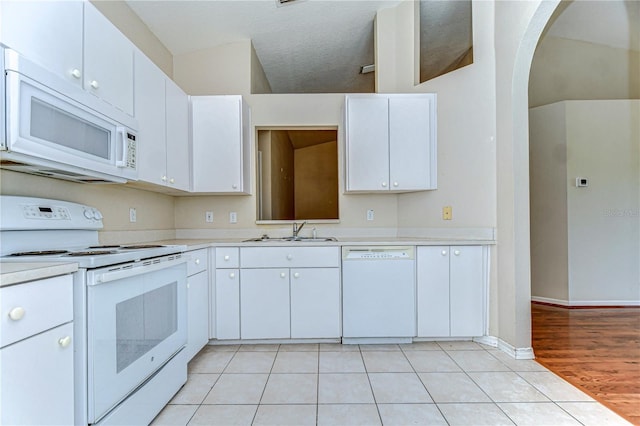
left=0, top=1, right=83, bottom=86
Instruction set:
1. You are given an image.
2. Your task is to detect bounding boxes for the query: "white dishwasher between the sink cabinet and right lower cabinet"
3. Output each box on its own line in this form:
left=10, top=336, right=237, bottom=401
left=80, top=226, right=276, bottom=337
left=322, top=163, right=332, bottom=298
left=342, top=246, right=416, bottom=343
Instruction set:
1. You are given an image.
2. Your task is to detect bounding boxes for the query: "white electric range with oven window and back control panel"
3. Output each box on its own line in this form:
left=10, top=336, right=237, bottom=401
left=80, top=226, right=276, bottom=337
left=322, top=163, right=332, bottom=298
left=0, top=196, right=187, bottom=424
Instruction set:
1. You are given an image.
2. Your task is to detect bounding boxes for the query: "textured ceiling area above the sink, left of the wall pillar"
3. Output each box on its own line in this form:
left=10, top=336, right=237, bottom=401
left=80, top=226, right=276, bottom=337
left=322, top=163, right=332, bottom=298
left=127, top=0, right=399, bottom=93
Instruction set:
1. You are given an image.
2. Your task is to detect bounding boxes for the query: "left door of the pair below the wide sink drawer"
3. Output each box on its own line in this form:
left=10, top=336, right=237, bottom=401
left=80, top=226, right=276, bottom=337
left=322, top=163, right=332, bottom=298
left=240, top=268, right=291, bottom=339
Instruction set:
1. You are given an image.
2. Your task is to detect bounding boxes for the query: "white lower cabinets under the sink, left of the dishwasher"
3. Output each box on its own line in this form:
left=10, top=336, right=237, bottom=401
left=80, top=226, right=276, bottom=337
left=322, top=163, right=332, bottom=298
left=215, top=246, right=341, bottom=340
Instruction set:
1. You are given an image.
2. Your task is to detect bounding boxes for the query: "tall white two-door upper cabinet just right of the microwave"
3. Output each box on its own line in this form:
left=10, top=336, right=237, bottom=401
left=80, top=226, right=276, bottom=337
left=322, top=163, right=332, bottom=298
left=135, top=51, right=190, bottom=191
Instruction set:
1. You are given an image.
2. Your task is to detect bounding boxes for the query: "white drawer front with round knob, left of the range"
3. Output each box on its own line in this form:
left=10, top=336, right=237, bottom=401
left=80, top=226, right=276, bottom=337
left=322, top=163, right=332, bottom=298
left=0, top=275, right=73, bottom=347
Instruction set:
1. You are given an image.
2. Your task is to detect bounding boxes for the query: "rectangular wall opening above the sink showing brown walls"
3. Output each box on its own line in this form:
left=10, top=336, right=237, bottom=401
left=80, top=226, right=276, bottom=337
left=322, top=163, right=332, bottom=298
left=256, top=128, right=339, bottom=221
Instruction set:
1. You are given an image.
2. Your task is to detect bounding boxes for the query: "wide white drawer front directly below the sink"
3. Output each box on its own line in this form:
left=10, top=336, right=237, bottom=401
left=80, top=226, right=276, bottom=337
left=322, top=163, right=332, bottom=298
left=240, top=247, right=340, bottom=268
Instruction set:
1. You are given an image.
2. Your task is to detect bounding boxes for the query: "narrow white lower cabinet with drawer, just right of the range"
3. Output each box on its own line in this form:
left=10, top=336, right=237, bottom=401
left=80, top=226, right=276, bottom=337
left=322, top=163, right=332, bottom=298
left=185, top=249, right=209, bottom=360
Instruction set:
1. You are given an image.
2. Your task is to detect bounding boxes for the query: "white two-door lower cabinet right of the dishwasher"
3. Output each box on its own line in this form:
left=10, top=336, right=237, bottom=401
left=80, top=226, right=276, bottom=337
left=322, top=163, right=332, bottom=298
left=416, top=246, right=487, bottom=337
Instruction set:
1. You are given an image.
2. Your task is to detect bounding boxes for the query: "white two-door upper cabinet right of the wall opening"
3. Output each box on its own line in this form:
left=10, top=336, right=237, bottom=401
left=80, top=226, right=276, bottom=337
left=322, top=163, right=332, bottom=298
left=345, top=94, right=437, bottom=192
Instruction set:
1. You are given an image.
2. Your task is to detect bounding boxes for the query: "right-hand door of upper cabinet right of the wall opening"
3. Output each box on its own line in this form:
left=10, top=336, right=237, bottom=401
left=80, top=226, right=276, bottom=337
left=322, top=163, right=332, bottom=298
left=389, top=96, right=435, bottom=191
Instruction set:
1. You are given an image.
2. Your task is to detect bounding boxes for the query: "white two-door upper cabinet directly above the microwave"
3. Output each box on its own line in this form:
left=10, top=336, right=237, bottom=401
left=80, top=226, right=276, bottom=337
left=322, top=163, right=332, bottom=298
left=0, top=0, right=134, bottom=115
